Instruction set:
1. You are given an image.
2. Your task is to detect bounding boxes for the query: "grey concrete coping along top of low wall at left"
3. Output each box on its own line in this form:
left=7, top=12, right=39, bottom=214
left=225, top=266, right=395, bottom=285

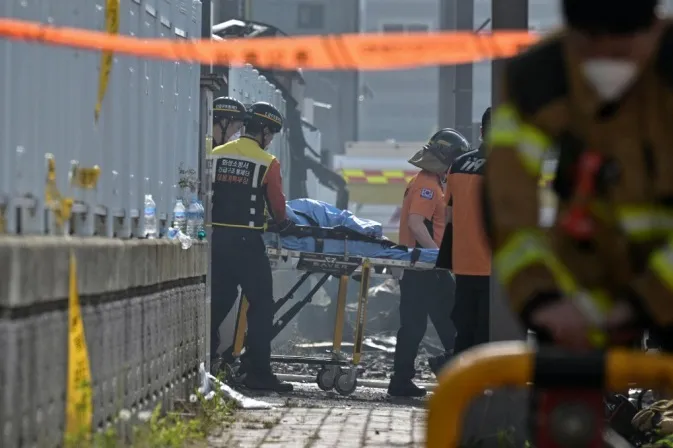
left=0, top=236, right=209, bottom=308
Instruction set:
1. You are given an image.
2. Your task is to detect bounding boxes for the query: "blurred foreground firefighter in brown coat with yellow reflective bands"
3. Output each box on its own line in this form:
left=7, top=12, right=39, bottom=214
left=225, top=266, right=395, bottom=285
left=485, top=0, right=673, bottom=350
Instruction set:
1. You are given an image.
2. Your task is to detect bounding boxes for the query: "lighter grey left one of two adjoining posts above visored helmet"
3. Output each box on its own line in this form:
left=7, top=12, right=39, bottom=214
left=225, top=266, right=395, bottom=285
left=437, top=0, right=457, bottom=129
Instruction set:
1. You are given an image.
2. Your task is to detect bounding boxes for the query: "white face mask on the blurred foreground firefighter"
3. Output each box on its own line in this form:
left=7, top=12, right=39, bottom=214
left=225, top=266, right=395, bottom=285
left=582, top=59, right=638, bottom=101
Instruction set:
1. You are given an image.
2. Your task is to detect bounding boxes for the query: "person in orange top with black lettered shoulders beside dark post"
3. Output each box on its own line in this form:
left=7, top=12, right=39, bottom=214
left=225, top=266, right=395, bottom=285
left=429, top=107, right=491, bottom=374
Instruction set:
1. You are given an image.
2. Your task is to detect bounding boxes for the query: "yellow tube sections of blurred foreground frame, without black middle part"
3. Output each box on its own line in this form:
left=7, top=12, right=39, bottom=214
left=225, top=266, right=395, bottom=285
left=426, top=342, right=673, bottom=448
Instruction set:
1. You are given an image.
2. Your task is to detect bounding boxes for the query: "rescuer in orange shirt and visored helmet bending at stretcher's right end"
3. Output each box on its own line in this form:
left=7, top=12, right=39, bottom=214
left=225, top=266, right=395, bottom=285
left=388, top=129, right=470, bottom=397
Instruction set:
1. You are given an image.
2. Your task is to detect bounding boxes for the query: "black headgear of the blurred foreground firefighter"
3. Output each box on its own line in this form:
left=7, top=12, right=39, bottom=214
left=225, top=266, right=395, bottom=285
left=563, top=0, right=659, bottom=34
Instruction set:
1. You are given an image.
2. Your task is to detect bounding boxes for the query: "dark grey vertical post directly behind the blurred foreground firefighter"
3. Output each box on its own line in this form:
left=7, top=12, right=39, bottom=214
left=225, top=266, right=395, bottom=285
left=490, top=0, right=528, bottom=341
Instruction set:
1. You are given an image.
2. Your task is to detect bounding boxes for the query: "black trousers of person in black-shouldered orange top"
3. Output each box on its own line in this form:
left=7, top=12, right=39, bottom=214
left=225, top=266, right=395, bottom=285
left=451, top=275, right=490, bottom=354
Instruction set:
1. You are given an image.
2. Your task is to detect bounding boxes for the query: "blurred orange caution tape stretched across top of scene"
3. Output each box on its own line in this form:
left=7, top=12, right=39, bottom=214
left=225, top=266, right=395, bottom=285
left=0, top=18, right=538, bottom=70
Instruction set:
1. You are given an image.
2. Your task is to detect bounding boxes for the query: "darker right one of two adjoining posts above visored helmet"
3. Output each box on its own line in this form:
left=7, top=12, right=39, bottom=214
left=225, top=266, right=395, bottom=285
left=452, top=0, right=474, bottom=140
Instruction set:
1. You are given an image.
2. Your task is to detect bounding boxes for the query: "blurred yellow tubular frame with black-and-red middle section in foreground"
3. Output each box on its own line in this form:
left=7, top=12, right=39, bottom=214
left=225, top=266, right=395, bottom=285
left=426, top=342, right=673, bottom=448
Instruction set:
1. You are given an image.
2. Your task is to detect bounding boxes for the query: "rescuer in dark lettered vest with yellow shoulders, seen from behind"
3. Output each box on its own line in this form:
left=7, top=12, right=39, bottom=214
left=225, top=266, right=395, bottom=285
left=211, top=103, right=292, bottom=392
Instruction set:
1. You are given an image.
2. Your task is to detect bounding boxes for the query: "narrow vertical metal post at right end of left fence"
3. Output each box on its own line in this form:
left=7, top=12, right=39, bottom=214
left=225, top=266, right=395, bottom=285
left=199, top=0, right=224, bottom=370
